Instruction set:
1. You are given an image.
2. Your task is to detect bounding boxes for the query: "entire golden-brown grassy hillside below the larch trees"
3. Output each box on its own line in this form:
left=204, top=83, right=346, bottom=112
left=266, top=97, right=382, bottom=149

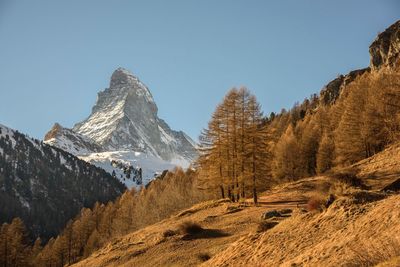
left=74, top=145, right=400, bottom=266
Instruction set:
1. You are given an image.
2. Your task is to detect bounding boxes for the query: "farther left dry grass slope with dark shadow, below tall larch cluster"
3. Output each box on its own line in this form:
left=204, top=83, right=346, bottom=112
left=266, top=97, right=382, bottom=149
left=74, top=200, right=265, bottom=266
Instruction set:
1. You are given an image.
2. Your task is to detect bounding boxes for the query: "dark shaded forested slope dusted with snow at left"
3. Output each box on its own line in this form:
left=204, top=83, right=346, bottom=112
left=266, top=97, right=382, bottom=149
left=0, top=124, right=126, bottom=239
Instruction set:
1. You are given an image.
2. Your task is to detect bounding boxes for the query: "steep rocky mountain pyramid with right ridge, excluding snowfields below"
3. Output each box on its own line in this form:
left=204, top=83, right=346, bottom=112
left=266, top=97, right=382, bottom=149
left=72, top=68, right=196, bottom=161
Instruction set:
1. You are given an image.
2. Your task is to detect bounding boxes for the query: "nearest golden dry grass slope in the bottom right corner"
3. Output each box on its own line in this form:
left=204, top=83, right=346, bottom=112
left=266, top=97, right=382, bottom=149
left=205, top=195, right=400, bottom=266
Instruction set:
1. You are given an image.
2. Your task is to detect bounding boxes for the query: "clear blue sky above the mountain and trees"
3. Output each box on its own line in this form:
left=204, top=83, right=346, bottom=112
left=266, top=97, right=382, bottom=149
left=0, top=0, right=400, bottom=142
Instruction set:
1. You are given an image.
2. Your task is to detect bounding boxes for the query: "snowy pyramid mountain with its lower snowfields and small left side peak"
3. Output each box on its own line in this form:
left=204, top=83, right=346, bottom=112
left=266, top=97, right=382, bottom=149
left=45, top=68, right=198, bottom=187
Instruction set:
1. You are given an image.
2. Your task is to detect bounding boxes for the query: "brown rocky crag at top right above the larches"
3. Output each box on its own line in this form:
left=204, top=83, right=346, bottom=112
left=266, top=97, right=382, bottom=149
left=369, top=20, right=400, bottom=69
